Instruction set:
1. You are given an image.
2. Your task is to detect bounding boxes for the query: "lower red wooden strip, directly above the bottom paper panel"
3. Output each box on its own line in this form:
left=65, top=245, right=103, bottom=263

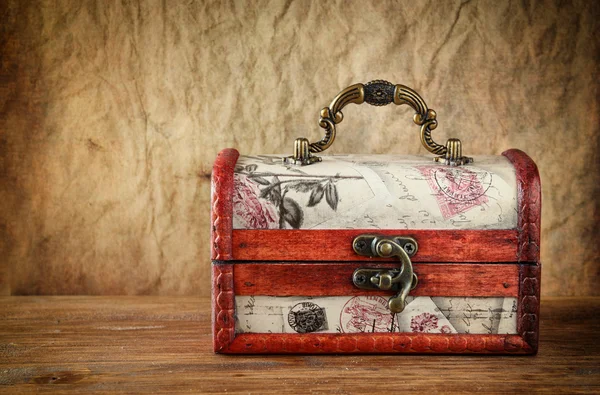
left=233, top=262, right=519, bottom=297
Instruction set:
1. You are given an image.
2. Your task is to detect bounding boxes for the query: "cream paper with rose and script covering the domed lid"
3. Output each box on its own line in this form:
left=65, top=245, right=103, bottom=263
left=233, top=155, right=517, bottom=229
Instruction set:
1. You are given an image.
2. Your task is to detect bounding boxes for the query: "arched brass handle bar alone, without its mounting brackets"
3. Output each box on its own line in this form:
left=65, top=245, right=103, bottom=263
left=310, top=80, right=447, bottom=155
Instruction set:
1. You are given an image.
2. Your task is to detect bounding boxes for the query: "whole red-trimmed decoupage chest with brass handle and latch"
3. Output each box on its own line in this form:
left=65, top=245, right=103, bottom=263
left=211, top=80, right=541, bottom=354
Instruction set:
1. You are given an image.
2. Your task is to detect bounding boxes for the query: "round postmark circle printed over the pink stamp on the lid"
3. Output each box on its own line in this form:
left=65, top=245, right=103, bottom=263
left=434, top=168, right=492, bottom=202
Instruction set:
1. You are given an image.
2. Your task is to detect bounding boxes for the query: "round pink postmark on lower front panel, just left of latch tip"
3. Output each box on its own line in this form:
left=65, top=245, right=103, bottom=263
left=340, top=296, right=395, bottom=333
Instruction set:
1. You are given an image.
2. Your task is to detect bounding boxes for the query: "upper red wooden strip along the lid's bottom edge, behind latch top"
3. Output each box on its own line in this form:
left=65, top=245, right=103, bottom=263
left=232, top=229, right=518, bottom=262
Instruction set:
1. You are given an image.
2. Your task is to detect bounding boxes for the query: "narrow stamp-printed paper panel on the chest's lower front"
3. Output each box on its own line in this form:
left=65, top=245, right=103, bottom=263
left=235, top=296, right=517, bottom=334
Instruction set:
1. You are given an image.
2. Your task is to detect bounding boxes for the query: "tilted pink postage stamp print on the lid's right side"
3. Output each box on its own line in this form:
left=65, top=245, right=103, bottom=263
left=417, top=166, right=492, bottom=219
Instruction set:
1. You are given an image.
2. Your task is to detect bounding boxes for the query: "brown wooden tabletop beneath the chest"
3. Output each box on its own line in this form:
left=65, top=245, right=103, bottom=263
left=0, top=297, right=600, bottom=394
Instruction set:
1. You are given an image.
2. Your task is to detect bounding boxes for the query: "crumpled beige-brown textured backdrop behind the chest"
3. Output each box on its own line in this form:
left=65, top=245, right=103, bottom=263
left=0, top=0, right=600, bottom=295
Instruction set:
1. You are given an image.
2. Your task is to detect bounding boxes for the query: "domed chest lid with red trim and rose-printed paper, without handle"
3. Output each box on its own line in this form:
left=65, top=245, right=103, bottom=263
left=212, top=149, right=541, bottom=262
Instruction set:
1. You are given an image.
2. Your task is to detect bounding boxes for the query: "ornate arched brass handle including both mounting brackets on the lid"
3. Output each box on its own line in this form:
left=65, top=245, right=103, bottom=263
left=284, top=80, right=472, bottom=165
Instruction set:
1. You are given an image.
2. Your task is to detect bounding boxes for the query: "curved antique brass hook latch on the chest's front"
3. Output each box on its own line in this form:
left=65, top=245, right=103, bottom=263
left=352, top=235, right=419, bottom=313
